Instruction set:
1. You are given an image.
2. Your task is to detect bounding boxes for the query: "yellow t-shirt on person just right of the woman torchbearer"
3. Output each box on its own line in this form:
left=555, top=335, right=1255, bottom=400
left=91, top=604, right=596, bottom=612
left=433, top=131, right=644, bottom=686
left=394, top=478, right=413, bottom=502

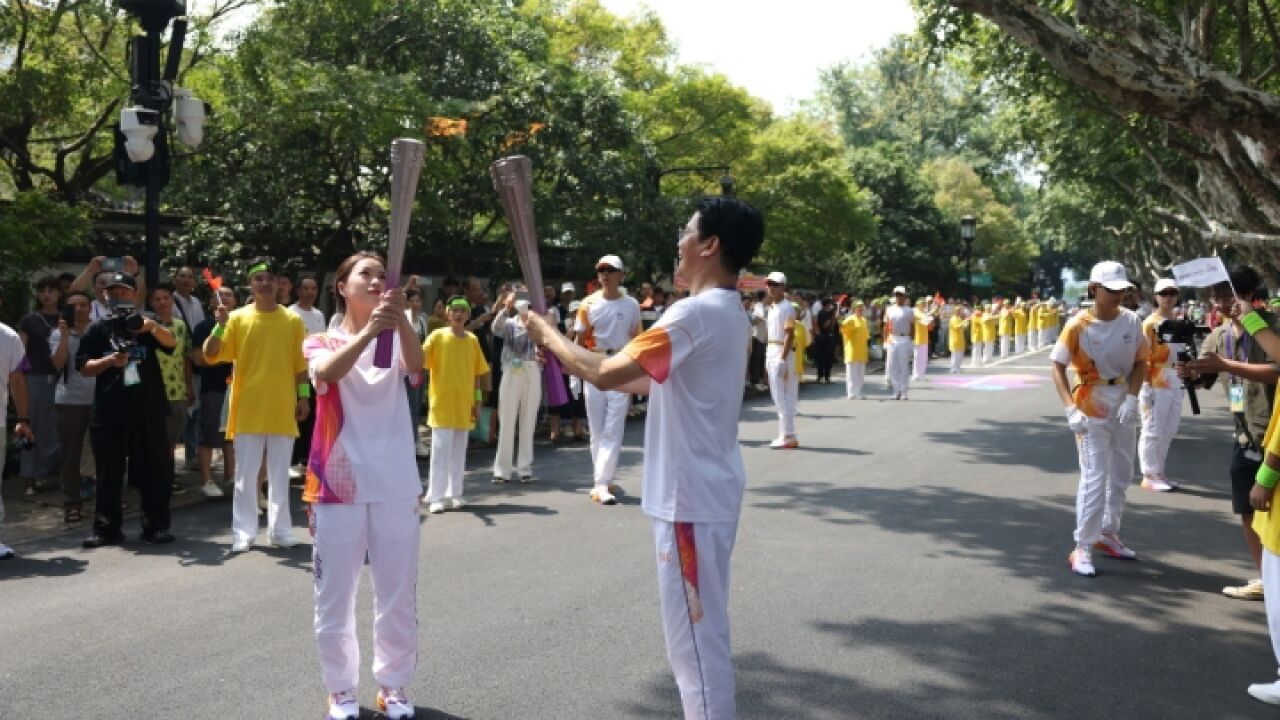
left=422, top=328, right=489, bottom=430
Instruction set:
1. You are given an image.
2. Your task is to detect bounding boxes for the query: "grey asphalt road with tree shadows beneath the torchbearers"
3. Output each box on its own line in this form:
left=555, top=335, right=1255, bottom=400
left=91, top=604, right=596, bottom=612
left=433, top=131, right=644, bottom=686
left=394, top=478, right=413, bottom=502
left=0, top=352, right=1277, bottom=720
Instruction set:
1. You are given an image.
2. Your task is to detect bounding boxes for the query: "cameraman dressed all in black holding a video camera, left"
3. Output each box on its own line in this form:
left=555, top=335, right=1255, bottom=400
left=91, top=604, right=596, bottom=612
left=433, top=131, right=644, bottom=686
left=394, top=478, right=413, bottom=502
left=76, top=273, right=177, bottom=548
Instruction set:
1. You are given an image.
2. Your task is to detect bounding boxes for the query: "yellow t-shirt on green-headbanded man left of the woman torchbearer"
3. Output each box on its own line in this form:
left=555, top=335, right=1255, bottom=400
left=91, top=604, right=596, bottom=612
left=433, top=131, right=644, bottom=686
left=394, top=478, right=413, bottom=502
left=206, top=305, right=307, bottom=439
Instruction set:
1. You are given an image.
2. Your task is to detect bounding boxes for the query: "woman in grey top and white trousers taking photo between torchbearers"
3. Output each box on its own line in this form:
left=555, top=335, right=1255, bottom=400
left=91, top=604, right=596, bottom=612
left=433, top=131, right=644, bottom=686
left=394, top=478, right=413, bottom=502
left=493, top=292, right=540, bottom=484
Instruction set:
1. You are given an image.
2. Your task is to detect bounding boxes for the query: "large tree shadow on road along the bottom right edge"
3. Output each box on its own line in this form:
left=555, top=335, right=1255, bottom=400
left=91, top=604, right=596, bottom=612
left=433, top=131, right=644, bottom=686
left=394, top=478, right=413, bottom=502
left=626, top=605, right=1271, bottom=720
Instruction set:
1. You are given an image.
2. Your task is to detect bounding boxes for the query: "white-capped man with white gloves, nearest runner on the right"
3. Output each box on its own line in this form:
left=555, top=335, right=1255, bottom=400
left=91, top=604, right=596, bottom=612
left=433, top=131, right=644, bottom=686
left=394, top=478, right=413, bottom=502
left=1050, top=261, right=1151, bottom=578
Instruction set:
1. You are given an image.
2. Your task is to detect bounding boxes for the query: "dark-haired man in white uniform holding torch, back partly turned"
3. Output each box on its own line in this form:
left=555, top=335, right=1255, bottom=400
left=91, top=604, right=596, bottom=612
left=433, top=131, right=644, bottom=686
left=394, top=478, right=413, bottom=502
left=530, top=197, right=764, bottom=720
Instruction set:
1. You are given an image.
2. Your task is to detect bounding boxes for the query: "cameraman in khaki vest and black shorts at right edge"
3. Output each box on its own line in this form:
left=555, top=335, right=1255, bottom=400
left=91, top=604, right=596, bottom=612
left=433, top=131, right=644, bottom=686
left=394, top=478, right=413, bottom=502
left=1178, top=266, right=1280, bottom=600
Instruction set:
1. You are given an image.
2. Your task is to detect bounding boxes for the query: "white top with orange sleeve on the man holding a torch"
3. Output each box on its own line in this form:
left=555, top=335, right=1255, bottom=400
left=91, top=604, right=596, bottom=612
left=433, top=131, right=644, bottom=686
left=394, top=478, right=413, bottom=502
left=622, top=288, right=750, bottom=523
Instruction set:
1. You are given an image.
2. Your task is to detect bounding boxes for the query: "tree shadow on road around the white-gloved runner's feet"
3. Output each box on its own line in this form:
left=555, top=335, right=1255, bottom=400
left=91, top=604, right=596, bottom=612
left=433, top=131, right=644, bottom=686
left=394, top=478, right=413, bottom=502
left=748, top=480, right=1245, bottom=604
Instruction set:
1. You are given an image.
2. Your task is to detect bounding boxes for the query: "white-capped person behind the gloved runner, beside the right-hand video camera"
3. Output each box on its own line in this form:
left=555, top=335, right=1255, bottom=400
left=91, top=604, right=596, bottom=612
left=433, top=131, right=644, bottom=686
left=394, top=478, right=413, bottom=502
left=1138, top=278, right=1190, bottom=492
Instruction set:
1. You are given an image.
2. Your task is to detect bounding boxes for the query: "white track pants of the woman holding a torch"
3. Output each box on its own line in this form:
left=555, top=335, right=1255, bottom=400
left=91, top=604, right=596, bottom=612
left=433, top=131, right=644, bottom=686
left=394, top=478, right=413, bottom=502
left=311, top=497, right=419, bottom=693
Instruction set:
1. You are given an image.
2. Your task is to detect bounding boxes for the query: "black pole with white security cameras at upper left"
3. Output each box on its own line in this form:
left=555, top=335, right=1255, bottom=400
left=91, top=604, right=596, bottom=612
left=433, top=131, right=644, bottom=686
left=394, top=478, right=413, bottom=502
left=115, top=0, right=205, bottom=287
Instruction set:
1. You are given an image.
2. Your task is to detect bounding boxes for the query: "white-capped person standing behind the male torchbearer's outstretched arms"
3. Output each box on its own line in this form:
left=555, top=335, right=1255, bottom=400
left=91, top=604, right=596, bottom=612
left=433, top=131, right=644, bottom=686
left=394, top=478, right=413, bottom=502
left=573, top=255, right=640, bottom=505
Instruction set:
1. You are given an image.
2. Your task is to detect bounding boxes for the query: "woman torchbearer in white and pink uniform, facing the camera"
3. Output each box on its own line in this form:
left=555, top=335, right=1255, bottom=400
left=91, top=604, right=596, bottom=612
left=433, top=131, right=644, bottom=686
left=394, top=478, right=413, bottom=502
left=302, top=252, right=422, bottom=720
